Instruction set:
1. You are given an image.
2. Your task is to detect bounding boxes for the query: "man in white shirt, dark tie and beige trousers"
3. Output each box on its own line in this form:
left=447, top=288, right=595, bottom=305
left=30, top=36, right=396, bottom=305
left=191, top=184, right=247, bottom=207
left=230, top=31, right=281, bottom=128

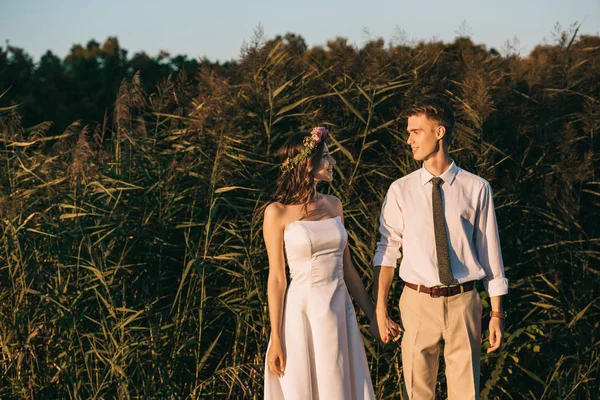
left=373, top=98, right=508, bottom=400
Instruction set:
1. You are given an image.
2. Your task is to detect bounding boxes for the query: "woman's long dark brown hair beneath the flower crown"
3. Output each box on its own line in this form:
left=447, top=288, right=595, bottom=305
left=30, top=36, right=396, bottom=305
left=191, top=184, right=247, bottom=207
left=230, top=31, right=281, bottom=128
left=267, top=132, right=325, bottom=209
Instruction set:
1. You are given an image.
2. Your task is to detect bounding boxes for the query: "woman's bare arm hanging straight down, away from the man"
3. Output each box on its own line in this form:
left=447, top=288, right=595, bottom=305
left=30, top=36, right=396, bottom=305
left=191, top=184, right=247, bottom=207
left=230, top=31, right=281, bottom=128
left=263, top=204, right=287, bottom=376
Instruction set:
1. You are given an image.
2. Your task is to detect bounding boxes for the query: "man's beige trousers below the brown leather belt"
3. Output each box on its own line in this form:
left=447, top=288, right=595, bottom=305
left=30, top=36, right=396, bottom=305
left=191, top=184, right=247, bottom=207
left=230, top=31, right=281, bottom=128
left=400, top=287, right=481, bottom=400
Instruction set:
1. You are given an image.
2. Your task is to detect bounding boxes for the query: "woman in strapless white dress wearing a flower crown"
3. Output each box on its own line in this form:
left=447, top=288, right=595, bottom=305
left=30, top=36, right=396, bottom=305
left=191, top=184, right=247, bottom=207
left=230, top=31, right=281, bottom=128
left=263, top=127, right=399, bottom=400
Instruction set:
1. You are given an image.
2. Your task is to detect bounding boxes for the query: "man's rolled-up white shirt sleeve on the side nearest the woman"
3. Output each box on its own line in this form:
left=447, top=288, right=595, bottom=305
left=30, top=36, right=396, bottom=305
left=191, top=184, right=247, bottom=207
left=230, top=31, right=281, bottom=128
left=373, top=184, right=404, bottom=268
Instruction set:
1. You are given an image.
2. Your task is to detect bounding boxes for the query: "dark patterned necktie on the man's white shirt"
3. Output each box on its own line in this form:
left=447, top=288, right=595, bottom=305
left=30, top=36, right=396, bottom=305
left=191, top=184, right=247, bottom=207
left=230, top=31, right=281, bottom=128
left=431, top=177, right=454, bottom=286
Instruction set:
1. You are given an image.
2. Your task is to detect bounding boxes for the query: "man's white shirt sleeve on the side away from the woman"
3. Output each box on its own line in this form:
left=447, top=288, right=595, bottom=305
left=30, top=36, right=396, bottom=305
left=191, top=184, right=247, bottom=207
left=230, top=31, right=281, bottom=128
left=475, top=182, right=508, bottom=297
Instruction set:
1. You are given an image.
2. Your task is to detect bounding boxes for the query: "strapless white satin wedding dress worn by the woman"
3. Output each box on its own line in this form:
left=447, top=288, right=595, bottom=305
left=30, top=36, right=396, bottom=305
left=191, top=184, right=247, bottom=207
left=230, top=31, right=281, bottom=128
left=265, top=217, right=375, bottom=400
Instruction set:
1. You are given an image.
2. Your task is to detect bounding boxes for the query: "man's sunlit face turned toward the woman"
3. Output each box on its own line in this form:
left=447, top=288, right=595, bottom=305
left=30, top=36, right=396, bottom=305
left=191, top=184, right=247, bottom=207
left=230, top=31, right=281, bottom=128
left=406, top=114, right=444, bottom=161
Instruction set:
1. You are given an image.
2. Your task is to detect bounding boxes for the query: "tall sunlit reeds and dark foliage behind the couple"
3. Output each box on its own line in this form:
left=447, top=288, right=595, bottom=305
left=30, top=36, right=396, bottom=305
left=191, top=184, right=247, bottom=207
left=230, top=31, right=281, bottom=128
left=0, top=29, right=600, bottom=399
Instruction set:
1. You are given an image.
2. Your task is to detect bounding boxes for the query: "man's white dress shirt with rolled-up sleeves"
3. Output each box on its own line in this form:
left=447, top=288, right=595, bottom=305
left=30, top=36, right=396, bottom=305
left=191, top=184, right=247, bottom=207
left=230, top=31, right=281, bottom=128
left=373, top=161, right=508, bottom=296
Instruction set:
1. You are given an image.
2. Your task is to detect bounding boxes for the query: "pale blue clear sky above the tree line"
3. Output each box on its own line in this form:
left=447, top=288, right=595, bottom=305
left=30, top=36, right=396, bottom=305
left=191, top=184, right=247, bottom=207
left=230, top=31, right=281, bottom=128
left=0, top=0, right=600, bottom=61
